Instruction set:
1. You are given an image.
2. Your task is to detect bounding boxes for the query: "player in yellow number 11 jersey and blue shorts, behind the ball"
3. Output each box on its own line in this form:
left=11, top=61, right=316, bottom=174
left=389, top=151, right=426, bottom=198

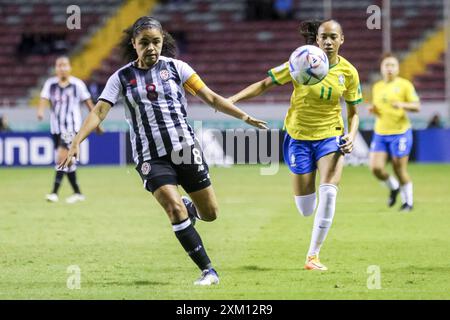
left=229, top=20, right=362, bottom=271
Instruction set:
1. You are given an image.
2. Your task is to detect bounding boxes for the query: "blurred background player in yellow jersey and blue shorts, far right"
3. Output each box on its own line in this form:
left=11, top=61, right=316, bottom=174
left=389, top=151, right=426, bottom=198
left=370, top=54, right=420, bottom=212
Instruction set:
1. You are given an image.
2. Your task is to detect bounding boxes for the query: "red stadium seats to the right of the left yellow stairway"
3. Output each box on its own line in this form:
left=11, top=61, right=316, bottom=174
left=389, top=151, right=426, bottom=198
left=89, top=0, right=443, bottom=104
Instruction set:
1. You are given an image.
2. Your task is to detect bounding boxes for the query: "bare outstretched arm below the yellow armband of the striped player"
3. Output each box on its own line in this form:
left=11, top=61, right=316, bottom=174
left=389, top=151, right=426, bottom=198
left=197, top=86, right=268, bottom=129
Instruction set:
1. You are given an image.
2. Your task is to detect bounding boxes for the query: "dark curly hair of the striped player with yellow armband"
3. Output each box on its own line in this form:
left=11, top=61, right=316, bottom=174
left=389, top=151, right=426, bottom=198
left=119, top=16, right=178, bottom=62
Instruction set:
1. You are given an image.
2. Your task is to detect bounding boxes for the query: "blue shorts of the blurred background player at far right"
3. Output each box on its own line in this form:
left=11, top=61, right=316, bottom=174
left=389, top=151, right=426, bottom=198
left=370, top=129, right=413, bottom=158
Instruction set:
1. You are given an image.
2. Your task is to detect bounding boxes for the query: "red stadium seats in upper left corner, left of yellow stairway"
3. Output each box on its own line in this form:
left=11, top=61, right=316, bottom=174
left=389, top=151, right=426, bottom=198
left=0, top=0, right=121, bottom=106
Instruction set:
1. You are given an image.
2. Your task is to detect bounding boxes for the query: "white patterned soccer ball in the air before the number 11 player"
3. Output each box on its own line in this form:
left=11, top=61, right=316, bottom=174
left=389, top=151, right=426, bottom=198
left=289, top=45, right=329, bottom=85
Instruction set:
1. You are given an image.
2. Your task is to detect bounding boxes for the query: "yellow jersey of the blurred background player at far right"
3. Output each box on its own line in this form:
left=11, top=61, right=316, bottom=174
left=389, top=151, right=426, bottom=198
left=372, top=77, right=419, bottom=135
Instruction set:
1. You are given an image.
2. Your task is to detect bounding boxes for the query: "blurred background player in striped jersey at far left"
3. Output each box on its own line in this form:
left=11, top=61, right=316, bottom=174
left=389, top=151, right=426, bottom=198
left=37, top=56, right=101, bottom=203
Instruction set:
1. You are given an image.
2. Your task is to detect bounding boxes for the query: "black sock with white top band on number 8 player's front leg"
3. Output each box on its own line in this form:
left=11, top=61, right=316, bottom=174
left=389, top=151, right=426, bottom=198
left=172, top=219, right=211, bottom=270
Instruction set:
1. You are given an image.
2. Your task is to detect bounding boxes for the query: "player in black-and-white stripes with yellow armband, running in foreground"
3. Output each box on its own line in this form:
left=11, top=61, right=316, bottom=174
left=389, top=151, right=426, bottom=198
left=61, top=16, right=267, bottom=285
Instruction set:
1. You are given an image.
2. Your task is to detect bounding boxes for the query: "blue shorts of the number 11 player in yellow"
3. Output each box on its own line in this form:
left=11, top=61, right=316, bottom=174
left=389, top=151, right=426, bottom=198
left=283, top=132, right=341, bottom=174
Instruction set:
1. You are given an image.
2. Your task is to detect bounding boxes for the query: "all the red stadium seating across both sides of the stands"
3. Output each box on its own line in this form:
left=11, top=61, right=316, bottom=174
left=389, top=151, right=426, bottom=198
left=0, top=0, right=444, bottom=105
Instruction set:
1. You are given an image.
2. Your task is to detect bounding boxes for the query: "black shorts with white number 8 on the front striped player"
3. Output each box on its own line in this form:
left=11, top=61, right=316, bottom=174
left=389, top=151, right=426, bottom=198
left=136, top=145, right=211, bottom=193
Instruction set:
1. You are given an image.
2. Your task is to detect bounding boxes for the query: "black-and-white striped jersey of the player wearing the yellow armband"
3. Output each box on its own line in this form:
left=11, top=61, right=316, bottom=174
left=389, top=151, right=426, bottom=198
left=99, top=56, right=203, bottom=163
